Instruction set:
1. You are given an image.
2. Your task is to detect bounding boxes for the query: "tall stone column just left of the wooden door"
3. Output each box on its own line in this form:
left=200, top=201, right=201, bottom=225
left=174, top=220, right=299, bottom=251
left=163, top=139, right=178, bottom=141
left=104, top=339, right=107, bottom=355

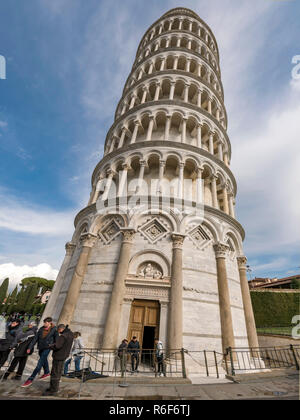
left=102, top=228, right=135, bottom=350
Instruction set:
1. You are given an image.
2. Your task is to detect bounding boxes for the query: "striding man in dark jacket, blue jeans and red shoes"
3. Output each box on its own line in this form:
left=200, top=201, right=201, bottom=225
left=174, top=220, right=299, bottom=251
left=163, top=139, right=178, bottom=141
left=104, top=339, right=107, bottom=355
left=22, top=317, right=58, bottom=388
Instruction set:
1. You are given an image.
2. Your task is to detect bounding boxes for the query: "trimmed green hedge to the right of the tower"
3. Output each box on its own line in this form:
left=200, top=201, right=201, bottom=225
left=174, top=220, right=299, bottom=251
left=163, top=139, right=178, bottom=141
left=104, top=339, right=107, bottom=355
left=250, top=290, right=300, bottom=327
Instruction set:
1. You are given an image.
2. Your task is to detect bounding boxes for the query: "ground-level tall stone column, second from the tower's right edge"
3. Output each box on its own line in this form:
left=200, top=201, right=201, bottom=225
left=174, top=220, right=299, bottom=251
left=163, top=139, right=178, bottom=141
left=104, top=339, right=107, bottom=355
left=214, top=243, right=235, bottom=353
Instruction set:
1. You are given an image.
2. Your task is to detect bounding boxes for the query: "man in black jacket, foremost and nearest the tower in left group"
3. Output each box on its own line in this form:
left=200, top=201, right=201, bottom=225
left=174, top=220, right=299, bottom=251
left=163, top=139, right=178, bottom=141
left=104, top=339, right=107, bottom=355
left=43, top=324, right=74, bottom=395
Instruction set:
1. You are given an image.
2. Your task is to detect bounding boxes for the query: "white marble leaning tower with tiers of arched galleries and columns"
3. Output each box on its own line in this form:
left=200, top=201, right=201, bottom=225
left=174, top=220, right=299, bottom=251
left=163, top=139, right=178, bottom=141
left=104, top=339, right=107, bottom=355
left=46, top=8, right=258, bottom=360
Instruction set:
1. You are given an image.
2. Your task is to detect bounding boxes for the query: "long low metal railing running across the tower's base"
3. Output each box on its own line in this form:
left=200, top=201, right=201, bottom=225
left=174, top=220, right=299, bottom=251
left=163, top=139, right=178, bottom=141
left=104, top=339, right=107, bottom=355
left=0, top=344, right=300, bottom=382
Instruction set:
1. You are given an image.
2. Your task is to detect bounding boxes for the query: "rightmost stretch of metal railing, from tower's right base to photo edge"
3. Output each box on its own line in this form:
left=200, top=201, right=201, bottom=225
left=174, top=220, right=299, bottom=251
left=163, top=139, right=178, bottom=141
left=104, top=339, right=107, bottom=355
left=224, top=344, right=300, bottom=375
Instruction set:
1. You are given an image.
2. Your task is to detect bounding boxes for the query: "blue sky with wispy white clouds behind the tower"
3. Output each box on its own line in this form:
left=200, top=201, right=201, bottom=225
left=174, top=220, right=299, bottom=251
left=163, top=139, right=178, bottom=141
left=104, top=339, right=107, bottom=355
left=0, top=0, right=300, bottom=288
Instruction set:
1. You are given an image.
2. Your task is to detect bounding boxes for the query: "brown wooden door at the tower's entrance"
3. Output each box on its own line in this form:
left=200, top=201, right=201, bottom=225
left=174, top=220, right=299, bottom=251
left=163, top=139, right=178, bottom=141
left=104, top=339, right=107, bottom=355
left=127, top=300, right=160, bottom=346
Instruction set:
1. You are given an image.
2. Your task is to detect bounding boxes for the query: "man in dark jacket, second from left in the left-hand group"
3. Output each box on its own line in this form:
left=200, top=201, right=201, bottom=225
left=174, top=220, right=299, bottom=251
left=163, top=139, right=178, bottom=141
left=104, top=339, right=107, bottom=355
left=3, top=321, right=37, bottom=380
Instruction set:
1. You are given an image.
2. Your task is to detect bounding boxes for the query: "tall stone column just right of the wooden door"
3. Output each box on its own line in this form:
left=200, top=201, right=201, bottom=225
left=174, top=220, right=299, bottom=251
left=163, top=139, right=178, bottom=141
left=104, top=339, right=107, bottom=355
left=168, top=233, right=185, bottom=350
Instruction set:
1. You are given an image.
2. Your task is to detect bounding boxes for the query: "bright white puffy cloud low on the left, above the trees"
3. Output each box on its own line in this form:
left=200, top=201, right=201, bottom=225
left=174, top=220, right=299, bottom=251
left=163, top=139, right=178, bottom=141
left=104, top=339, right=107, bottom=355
left=0, top=263, right=58, bottom=290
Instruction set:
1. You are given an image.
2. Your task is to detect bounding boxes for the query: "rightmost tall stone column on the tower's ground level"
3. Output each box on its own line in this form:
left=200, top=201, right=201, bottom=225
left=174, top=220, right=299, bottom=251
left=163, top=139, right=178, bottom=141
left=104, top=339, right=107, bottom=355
left=237, top=256, right=259, bottom=347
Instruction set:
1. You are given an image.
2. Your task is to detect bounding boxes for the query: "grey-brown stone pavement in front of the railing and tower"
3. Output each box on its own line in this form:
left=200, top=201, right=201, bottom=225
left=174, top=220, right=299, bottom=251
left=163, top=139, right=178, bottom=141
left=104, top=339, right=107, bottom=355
left=0, top=370, right=299, bottom=400
